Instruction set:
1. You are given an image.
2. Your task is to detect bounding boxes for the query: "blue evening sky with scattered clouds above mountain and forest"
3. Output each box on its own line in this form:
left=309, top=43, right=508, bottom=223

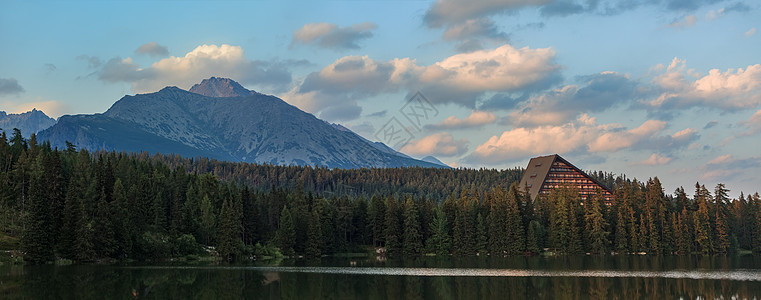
left=0, top=0, right=761, bottom=197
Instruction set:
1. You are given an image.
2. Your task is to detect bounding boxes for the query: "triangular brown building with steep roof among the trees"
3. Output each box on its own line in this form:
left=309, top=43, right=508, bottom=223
left=520, top=154, right=613, bottom=205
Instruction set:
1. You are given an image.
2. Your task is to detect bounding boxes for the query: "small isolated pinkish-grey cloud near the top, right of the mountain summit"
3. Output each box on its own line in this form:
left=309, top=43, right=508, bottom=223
left=291, top=22, right=378, bottom=50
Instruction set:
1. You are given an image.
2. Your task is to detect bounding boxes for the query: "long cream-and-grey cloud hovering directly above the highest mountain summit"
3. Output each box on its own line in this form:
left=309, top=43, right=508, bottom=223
left=89, top=44, right=291, bottom=93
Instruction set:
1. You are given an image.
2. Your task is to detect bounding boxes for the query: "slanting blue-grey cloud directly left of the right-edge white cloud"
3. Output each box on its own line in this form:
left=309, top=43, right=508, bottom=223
left=506, top=72, right=644, bottom=127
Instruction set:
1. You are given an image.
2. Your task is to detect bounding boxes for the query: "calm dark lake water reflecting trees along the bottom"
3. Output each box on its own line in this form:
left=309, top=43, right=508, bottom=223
left=0, top=256, right=761, bottom=300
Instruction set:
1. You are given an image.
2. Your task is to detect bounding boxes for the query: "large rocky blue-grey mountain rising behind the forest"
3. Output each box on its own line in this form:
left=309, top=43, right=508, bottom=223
left=38, top=77, right=441, bottom=168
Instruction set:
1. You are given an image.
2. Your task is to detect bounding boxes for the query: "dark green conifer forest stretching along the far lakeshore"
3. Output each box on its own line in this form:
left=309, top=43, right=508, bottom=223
left=0, top=130, right=761, bottom=263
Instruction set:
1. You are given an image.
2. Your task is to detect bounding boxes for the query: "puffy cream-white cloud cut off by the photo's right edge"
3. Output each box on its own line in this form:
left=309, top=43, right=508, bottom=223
left=642, top=58, right=761, bottom=111
